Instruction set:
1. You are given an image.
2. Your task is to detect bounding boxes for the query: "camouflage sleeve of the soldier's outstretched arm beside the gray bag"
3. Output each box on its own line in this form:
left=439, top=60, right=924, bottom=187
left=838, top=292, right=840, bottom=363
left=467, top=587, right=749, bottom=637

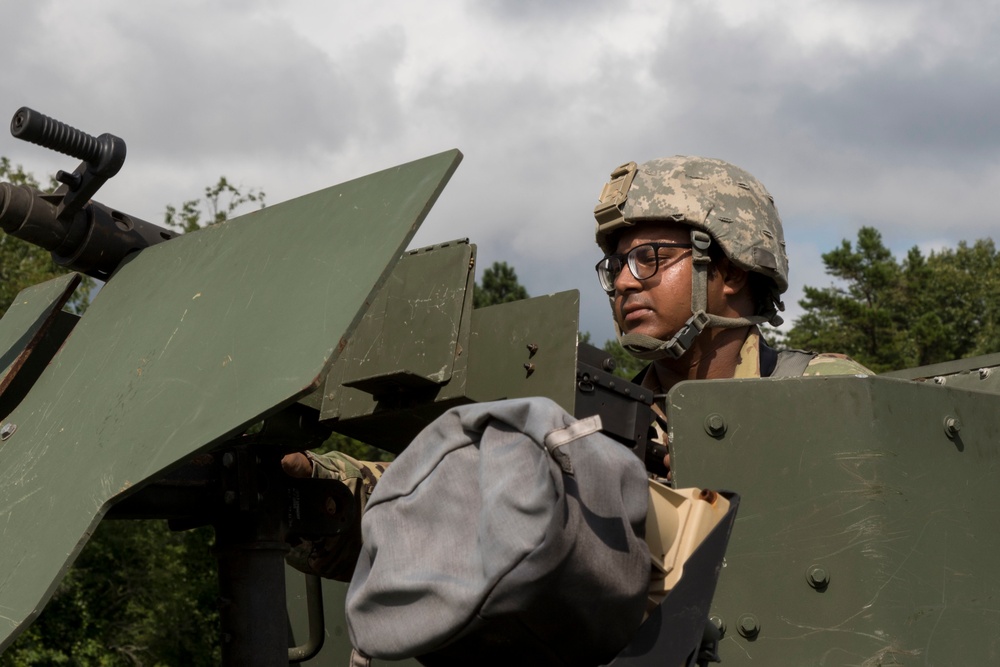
left=285, top=452, right=389, bottom=581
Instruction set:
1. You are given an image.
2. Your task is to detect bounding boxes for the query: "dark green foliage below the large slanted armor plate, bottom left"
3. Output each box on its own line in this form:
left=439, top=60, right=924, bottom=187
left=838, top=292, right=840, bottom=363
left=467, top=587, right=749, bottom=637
left=0, top=521, right=220, bottom=667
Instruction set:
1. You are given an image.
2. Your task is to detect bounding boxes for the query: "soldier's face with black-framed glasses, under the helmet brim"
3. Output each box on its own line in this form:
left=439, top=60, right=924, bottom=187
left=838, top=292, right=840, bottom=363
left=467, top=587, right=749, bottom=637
left=614, top=223, right=691, bottom=340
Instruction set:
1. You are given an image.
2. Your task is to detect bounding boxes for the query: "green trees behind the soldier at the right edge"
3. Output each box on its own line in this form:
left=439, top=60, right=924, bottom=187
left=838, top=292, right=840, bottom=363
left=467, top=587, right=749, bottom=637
left=784, top=227, right=1000, bottom=371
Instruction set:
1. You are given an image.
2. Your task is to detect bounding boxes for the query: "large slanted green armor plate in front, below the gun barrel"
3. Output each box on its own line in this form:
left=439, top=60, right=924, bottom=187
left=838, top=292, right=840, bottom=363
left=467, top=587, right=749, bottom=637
left=0, top=151, right=461, bottom=650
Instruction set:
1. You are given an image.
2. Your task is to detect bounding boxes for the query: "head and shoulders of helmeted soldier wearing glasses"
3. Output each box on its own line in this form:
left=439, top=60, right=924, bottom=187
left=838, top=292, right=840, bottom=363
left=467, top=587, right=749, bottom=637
left=594, top=156, right=871, bottom=469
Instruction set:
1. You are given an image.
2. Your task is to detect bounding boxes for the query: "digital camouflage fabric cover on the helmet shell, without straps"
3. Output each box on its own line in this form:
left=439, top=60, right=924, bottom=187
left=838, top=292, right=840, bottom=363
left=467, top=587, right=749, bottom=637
left=594, top=155, right=788, bottom=300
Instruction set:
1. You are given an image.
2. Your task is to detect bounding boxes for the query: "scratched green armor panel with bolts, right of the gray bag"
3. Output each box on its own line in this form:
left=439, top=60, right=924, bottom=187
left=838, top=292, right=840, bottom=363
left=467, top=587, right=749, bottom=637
left=667, top=376, right=1000, bottom=667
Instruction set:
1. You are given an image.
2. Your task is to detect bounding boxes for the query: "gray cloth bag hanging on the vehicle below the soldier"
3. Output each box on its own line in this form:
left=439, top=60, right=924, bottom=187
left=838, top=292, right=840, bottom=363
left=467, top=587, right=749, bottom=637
left=347, top=398, right=650, bottom=665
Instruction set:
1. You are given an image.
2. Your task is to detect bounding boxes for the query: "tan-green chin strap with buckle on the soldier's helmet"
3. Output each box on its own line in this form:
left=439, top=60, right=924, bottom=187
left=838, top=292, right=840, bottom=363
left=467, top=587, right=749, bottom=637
left=618, top=229, right=771, bottom=361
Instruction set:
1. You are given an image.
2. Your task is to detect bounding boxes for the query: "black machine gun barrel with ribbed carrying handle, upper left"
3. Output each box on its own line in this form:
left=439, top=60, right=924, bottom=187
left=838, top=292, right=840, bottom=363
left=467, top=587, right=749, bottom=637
left=0, top=107, right=177, bottom=280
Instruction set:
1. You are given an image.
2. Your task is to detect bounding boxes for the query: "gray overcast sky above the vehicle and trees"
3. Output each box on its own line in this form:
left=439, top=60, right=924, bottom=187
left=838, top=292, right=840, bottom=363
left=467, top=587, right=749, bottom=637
left=0, top=0, right=1000, bottom=342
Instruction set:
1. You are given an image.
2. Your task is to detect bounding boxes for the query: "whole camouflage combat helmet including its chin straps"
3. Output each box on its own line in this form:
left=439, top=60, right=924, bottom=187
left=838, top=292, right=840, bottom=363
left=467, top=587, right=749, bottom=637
left=594, top=155, right=788, bottom=359
